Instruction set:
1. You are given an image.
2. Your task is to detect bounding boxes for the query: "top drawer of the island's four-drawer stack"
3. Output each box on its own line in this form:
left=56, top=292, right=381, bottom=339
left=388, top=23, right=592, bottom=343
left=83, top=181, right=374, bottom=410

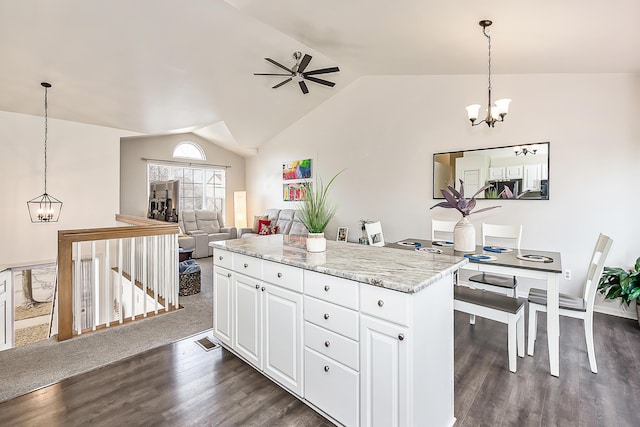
left=304, top=270, right=359, bottom=310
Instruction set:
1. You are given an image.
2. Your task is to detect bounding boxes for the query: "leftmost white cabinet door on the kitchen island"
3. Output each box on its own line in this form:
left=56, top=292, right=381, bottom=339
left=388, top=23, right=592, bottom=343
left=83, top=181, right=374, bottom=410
left=213, top=267, right=233, bottom=346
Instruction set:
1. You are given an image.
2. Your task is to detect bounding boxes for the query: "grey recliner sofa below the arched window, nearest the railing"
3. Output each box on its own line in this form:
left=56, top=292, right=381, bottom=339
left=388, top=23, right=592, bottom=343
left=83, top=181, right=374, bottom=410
left=178, top=209, right=238, bottom=258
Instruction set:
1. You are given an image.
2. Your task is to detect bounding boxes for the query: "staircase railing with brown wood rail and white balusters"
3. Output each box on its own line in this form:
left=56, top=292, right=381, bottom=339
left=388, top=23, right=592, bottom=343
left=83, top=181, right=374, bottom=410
left=56, top=215, right=179, bottom=341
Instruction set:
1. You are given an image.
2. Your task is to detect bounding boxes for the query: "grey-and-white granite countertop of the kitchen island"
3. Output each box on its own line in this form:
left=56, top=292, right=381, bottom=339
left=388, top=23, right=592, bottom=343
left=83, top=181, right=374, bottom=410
left=209, top=234, right=468, bottom=293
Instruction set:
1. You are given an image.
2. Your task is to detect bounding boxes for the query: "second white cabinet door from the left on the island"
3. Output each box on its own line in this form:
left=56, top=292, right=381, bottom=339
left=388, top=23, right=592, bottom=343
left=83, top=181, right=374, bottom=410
left=231, top=273, right=262, bottom=369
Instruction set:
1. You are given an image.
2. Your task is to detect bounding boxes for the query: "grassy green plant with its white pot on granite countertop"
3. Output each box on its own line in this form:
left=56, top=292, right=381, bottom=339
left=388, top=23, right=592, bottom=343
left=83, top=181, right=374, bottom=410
left=298, top=171, right=343, bottom=252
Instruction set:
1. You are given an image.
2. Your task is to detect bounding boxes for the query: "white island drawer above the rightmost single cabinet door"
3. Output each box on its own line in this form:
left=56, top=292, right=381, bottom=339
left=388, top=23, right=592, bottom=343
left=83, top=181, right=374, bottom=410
left=360, top=284, right=410, bottom=326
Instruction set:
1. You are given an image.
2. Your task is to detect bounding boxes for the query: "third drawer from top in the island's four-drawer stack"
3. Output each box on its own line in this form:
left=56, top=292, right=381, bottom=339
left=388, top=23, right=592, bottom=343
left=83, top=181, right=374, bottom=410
left=304, top=322, right=360, bottom=371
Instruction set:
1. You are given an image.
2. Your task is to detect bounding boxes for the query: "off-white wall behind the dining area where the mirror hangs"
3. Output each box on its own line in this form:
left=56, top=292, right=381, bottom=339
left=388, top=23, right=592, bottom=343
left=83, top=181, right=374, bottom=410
left=247, top=74, right=640, bottom=317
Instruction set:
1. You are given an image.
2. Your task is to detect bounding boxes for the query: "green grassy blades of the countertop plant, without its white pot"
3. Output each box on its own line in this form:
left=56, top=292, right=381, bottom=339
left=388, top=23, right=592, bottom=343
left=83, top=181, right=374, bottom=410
left=298, top=170, right=344, bottom=233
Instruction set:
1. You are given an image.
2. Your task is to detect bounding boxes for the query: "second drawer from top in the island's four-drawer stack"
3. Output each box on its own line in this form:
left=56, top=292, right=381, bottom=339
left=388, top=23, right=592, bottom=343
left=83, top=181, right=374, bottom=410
left=304, top=296, right=360, bottom=341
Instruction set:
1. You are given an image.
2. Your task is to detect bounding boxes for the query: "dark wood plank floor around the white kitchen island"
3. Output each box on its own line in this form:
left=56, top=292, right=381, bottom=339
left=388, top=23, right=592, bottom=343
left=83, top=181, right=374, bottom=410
left=0, top=313, right=640, bottom=427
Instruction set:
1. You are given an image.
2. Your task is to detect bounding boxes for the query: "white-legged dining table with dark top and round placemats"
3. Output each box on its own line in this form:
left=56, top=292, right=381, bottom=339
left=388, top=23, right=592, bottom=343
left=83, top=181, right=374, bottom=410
left=385, top=238, right=562, bottom=377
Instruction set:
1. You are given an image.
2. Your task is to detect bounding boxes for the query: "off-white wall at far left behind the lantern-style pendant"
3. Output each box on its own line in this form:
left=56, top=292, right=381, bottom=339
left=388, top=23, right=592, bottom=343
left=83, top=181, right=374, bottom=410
left=0, top=111, right=134, bottom=265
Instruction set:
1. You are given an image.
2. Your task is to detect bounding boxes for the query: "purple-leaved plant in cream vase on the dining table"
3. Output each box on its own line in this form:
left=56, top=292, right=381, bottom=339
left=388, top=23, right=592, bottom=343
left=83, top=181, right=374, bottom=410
left=431, top=180, right=500, bottom=252
